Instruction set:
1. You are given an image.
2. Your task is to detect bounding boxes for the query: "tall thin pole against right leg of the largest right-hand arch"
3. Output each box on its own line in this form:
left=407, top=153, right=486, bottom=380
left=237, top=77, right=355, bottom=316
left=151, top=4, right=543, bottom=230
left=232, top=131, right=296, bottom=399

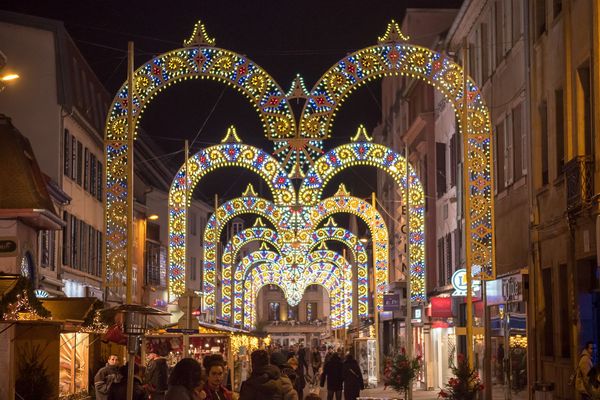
left=461, top=38, right=474, bottom=369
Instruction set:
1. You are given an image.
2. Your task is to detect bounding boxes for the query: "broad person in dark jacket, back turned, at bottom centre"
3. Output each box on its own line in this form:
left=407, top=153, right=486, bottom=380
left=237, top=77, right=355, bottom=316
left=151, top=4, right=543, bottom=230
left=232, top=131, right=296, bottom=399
left=239, top=350, right=300, bottom=400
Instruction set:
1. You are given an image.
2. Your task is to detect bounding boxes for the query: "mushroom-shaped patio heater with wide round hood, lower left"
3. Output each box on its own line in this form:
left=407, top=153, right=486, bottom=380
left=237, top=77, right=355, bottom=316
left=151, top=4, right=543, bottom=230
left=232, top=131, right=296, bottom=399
left=113, top=304, right=169, bottom=400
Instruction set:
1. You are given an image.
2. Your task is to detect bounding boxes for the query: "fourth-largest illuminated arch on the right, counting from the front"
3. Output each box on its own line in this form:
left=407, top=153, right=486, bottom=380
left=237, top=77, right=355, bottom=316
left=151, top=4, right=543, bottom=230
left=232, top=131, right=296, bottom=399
left=309, top=221, right=369, bottom=318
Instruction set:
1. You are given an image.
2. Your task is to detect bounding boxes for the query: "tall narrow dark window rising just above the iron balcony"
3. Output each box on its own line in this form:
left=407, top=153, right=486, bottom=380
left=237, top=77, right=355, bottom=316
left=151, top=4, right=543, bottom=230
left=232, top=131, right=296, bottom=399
left=577, top=63, right=595, bottom=156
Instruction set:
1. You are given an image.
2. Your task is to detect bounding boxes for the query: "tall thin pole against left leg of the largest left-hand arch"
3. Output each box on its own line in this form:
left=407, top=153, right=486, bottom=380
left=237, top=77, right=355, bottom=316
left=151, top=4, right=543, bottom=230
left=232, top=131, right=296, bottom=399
left=126, top=42, right=135, bottom=304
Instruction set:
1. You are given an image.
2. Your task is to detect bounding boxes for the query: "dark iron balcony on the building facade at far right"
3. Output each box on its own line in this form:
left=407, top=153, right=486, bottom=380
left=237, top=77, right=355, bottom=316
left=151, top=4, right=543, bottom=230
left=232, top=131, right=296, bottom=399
left=564, top=155, right=594, bottom=213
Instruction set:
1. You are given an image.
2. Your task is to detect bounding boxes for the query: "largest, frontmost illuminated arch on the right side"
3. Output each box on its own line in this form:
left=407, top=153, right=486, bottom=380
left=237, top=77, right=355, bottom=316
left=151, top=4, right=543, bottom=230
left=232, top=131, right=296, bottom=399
left=299, top=21, right=496, bottom=282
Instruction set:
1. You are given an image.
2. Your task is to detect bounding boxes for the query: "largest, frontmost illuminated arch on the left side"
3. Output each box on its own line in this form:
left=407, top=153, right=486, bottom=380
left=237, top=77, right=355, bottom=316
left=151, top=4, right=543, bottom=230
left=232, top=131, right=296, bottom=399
left=104, top=22, right=296, bottom=292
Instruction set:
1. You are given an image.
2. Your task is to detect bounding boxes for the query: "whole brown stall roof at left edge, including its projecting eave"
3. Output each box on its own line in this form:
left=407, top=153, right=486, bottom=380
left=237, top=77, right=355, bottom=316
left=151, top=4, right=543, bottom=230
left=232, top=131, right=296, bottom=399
left=0, top=114, right=61, bottom=229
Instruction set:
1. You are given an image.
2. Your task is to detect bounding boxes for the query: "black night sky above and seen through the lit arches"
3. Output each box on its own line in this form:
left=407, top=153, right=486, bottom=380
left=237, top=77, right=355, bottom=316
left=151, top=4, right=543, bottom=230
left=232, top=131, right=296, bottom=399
left=0, top=0, right=461, bottom=205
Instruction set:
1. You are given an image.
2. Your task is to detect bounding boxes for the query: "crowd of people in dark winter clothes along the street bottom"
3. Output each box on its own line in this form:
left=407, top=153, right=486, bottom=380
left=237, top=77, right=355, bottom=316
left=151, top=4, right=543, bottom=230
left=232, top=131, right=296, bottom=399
left=94, top=345, right=364, bottom=400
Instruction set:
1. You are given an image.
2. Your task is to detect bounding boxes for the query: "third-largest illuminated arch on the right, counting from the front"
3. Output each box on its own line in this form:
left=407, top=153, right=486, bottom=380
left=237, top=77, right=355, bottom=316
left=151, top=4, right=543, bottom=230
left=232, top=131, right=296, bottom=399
left=309, top=188, right=389, bottom=310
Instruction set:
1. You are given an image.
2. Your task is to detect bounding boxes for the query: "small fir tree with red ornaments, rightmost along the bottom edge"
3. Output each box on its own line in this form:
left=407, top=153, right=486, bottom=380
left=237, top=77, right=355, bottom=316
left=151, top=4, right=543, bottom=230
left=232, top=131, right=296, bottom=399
left=438, top=354, right=483, bottom=400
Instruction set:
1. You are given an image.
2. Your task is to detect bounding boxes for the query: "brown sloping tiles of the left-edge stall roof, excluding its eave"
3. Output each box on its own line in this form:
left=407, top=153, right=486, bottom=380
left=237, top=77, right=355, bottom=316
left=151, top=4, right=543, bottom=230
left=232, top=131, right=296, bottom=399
left=0, top=114, right=56, bottom=215
